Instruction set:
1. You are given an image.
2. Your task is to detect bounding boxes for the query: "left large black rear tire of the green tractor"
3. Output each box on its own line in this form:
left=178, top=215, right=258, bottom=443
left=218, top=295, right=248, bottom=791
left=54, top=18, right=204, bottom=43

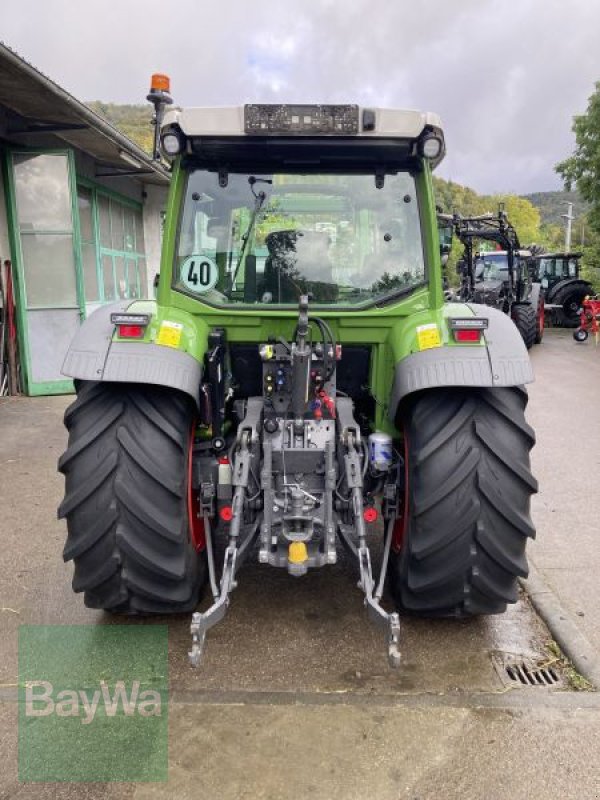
left=58, top=382, right=206, bottom=614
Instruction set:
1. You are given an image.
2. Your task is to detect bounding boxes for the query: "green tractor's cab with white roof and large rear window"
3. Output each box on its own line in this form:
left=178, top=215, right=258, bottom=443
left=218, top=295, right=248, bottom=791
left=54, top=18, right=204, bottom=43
left=157, top=105, right=444, bottom=311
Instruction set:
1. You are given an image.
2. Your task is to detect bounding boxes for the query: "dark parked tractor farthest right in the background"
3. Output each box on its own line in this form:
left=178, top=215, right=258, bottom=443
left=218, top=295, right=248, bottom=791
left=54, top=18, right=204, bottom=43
left=530, top=253, right=594, bottom=328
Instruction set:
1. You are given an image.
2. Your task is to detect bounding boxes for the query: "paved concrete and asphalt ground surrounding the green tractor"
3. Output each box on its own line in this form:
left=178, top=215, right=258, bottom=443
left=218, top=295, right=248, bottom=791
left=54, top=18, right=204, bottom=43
left=0, top=331, right=600, bottom=800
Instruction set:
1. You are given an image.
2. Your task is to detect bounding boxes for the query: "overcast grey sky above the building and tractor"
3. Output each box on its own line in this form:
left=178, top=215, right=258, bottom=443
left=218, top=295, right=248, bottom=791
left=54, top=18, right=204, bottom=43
left=0, top=0, right=600, bottom=193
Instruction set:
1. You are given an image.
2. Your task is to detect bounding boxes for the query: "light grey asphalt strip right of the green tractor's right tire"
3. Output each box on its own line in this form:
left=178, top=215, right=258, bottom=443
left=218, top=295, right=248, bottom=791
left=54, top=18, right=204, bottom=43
left=528, top=329, right=600, bottom=651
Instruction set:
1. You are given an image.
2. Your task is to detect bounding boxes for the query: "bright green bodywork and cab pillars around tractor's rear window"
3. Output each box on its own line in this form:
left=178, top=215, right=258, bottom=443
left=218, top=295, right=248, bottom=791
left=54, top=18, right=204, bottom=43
left=119, top=160, right=485, bottom=433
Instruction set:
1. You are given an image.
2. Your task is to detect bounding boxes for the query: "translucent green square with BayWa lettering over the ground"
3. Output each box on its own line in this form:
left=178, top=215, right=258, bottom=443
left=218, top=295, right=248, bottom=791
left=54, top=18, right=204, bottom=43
left=19, top=625, right=168, bottom=781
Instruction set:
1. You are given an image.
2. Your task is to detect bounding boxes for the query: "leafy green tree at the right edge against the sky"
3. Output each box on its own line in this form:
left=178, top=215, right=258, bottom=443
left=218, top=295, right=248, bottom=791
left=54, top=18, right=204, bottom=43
left=555, top=81, right=600, bottom=234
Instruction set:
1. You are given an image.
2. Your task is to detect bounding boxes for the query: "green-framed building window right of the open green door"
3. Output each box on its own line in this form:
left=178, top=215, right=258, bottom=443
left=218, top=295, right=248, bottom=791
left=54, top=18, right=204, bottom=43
left=77, top=185, right=147, bottom=304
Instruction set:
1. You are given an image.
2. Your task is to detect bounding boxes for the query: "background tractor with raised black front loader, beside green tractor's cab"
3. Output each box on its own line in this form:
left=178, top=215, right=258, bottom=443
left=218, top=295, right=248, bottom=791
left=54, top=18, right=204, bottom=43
left=454, top=209, right=544, bottom=349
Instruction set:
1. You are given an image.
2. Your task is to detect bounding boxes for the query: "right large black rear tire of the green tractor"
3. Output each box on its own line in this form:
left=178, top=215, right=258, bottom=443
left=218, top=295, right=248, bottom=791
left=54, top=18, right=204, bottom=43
left=388, top=388, right=537, bottom=617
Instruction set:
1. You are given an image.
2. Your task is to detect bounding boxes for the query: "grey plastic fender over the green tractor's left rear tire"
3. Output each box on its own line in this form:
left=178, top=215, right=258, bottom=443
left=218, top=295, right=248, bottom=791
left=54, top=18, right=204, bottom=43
left=62, top=300, right=202, bottom=405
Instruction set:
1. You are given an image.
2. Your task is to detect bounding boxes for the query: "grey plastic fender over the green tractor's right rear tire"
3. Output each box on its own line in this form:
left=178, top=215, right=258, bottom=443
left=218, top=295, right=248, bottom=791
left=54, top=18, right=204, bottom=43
left=389, top=303, right=534, bottom=420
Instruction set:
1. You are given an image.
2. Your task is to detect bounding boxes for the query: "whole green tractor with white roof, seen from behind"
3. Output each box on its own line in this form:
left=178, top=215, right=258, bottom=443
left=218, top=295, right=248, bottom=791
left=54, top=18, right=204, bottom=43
left=59, top=85, right=536, bottom=665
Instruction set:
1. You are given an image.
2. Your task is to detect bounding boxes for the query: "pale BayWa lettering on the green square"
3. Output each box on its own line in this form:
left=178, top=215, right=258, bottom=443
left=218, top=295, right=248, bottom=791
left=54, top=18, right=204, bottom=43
left=25, top=681, right=162, bottom=725
